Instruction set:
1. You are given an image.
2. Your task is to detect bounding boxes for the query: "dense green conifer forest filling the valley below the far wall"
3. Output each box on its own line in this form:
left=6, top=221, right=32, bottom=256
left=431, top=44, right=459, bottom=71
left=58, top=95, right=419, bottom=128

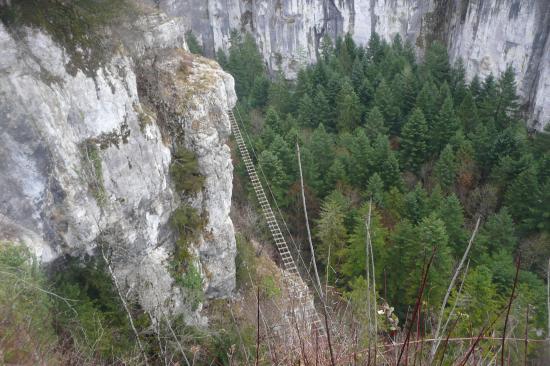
left=224, top=30, right=550, bottom=358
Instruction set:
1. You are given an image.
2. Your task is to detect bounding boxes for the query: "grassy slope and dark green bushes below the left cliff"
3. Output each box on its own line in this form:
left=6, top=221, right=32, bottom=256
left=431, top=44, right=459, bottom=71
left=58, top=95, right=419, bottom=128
left=0, top=242, right=150, bottom=364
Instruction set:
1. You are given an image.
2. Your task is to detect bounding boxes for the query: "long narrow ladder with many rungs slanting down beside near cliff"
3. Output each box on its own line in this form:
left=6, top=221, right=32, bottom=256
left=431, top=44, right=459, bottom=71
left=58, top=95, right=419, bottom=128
left=227, top=110, right=326, bottom=337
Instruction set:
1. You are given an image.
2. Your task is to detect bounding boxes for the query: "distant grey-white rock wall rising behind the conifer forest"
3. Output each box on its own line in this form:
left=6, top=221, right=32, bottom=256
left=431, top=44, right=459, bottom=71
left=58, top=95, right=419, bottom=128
left=166, top=0, right=550, bottom=129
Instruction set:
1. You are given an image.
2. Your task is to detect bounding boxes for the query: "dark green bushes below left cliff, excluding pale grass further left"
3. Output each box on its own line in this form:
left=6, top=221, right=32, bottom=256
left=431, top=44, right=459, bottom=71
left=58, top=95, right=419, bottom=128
left=53, top=257, right=150, bottom=360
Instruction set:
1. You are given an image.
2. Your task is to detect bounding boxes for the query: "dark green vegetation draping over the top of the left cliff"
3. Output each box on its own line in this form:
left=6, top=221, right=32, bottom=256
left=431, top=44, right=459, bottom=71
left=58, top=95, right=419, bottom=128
left=0, top=0, right=136, bottom=76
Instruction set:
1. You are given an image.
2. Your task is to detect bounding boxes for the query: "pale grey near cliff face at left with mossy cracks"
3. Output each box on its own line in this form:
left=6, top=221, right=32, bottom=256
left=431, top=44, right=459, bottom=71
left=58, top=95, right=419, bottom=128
left=0, top=15, right=236, bottom=322
